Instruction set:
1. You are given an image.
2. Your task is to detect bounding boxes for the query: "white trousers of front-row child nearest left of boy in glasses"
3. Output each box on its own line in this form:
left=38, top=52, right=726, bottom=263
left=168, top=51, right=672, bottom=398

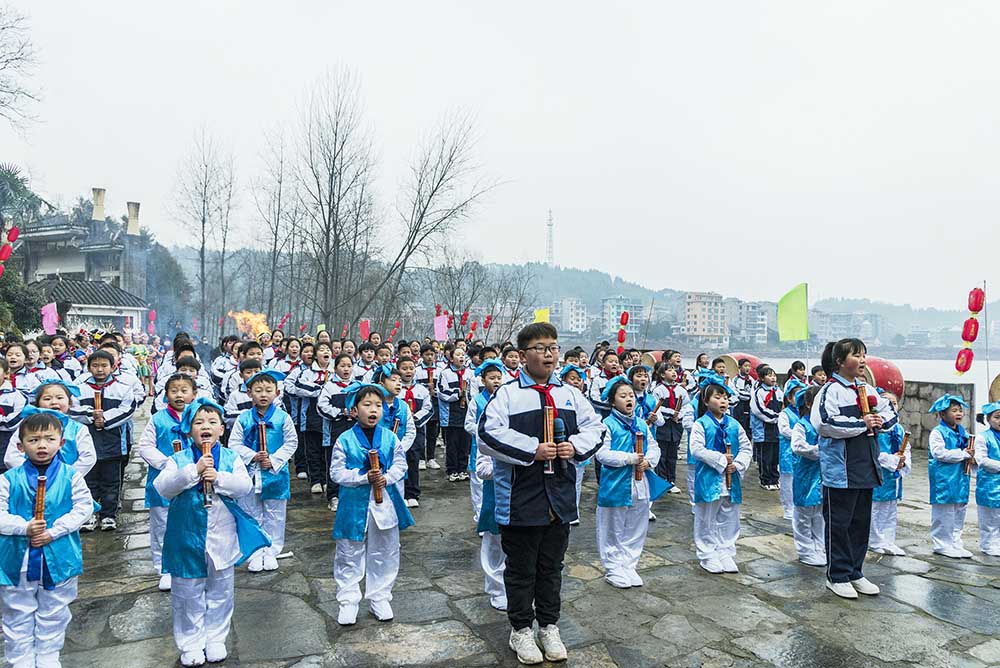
left=333, top=515, right=399, bottom=605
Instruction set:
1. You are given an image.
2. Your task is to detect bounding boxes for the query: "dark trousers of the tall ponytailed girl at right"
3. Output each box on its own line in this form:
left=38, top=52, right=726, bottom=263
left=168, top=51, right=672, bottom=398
left=823, top=486, right=872, bottom=582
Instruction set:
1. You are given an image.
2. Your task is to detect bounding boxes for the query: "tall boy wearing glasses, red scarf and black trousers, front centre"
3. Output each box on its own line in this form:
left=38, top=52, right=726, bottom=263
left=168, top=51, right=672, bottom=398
left=478, top=323, right=604, bottom=664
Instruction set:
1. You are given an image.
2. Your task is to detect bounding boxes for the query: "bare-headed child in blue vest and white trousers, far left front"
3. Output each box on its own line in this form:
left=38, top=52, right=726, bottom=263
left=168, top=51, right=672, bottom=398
left=0, top=412, right=93, bottom=666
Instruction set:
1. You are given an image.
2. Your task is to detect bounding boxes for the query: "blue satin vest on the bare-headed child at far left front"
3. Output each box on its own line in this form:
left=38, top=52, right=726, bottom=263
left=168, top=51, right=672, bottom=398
left=0, top=459, right=83, bottom=587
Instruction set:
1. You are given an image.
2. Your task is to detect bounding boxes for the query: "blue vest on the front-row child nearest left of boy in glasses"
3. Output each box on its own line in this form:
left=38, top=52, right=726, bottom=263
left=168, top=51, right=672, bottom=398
left=333, top=425, right=413, bottom=542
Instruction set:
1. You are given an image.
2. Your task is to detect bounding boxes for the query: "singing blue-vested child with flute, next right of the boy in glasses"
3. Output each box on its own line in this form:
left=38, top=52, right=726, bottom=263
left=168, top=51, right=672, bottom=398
left=595, top=376, right=668, bottom=589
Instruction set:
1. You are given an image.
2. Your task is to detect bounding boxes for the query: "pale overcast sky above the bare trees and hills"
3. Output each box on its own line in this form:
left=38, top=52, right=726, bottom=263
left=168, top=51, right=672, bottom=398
left=0, top=0, right=1000, bottom=308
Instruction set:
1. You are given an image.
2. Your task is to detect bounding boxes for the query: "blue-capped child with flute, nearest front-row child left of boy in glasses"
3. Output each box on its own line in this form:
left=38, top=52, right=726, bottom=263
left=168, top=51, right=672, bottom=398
left=330, top=383, right=413, bottom=626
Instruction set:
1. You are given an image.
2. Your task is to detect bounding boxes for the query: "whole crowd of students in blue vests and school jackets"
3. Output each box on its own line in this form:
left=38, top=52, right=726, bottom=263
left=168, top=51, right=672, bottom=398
left=0, top=323, right=1000, bottom=666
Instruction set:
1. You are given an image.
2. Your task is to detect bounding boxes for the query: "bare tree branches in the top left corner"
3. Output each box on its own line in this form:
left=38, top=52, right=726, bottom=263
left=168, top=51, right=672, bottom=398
left=0, top=6, right=38, bottom=127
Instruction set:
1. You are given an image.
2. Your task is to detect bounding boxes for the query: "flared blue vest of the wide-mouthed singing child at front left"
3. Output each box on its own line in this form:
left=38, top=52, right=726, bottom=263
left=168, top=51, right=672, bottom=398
left=163, top=443, right=271, bottom=579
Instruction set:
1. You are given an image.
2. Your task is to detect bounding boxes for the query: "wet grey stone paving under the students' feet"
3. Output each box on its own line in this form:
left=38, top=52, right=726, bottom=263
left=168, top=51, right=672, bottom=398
left=54, top=418, right=1000, bottom=668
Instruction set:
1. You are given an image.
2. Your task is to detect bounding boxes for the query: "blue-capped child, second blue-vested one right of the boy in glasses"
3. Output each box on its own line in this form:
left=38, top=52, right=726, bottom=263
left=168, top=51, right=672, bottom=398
left=689, top=374, right=753, bottom=574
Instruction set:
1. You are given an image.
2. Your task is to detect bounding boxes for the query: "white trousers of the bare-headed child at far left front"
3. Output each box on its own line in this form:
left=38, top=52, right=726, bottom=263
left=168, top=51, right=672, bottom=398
left=0, top=572, right=76, bottom=668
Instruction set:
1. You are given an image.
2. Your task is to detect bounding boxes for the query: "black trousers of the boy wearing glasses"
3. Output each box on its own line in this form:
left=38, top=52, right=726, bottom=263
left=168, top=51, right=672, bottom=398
left=500, top=523, right=569, bottom=630
